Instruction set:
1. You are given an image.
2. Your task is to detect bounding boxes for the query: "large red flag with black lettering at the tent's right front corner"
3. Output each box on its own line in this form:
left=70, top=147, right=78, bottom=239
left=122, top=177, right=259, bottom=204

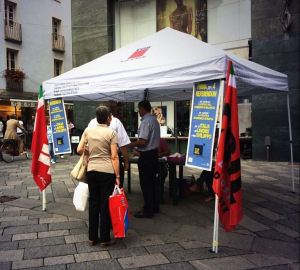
left=213, top=61, right=243, bottom=231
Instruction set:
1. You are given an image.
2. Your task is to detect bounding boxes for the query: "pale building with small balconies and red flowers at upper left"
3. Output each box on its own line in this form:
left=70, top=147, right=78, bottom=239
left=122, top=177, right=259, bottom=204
left=0, top=0, right=72, bottom=129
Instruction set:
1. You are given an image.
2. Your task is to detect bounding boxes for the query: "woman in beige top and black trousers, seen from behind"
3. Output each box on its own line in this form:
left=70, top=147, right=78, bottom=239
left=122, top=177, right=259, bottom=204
left=77, top=106, right=120, bottom=246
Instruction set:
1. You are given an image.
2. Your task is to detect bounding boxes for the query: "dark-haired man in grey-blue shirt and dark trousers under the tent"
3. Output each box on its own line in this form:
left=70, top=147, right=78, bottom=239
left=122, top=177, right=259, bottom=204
left=130, top=100, right=160, bottom=218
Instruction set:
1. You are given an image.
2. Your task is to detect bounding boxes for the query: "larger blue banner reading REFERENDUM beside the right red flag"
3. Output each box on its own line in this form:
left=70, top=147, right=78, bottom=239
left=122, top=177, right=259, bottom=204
left=185, top=80, right=224, bottom=171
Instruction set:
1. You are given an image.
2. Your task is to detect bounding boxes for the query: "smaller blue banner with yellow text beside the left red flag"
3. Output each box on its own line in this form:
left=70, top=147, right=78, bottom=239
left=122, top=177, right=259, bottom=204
left=49, top=98, right=71, bottom=155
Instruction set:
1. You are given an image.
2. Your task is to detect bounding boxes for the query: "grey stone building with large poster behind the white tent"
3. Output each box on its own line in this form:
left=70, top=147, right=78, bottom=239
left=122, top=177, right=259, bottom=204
left=72, top=0, right=299, bottom=160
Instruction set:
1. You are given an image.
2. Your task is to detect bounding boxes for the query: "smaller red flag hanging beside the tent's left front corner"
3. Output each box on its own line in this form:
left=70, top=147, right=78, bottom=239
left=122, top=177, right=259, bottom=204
left=31, top=86, right=51, bottom=191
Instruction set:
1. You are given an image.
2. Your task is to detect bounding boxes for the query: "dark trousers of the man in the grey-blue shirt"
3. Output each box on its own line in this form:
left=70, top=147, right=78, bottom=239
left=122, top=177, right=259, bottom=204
left=138, top=149, right=159, bottom=216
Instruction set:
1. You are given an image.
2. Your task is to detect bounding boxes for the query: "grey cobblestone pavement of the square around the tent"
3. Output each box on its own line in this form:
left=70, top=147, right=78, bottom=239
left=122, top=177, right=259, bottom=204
left=0, top=156, right=300, bottom=270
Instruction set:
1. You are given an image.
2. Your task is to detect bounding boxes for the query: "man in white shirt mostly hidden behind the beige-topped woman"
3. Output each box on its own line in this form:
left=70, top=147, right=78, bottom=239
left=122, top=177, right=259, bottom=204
left=88, top=116, right=130, bottom=187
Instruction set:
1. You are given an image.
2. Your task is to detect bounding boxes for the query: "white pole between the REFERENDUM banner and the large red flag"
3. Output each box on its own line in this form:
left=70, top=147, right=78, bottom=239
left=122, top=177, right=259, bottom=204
left=212, top=78, right=225, bottom=253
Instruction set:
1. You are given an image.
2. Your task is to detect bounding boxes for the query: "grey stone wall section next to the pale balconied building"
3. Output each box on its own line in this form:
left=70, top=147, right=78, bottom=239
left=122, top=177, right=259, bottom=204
left=72, top=0, right=113, bottom=129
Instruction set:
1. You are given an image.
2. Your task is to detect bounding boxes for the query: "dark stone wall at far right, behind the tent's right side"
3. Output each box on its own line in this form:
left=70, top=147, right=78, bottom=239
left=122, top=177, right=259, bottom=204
left=251, top=0, right=300, bottom=161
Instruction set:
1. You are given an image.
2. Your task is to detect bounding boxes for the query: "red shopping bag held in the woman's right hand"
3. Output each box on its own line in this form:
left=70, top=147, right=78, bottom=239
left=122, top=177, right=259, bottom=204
left=109, top=185, right=128, bottom=238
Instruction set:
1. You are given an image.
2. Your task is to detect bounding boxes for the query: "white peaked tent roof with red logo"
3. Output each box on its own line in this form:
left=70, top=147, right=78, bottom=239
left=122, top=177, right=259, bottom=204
left=43, top=28, right=288, bottom=101
